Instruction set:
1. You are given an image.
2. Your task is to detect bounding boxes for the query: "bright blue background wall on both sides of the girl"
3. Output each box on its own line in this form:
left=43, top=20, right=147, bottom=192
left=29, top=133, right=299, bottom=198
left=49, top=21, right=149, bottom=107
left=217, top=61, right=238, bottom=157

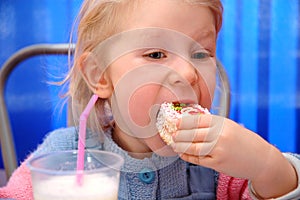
left=0, top=0, right=300, bottom=168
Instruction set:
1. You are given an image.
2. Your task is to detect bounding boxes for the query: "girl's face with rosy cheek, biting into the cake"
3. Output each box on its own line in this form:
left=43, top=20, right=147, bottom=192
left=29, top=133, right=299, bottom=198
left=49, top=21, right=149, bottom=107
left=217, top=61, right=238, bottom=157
left=96, top=0, right=216, bottom=155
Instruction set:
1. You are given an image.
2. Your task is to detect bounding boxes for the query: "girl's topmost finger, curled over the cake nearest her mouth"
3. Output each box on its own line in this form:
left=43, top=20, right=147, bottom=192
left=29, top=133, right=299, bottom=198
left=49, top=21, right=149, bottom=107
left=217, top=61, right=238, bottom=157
left=177, top=114, right=212, bottom=129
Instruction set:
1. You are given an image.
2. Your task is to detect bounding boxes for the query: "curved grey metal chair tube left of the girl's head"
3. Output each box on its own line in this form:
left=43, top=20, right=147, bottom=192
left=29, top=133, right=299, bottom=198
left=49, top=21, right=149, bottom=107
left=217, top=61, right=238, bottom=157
left=0, top=44, right=74, bottom=178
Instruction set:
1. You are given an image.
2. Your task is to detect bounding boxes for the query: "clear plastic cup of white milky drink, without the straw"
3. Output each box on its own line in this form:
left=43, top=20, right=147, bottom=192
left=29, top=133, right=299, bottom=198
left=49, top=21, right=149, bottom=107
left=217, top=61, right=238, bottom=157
left=28, top=150, right=124, bottom=200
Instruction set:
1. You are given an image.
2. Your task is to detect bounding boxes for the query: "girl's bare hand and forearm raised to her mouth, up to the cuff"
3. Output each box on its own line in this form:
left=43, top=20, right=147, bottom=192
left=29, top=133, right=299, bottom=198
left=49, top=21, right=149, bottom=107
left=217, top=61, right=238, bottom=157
left=172, top=115, right=297, bottom=197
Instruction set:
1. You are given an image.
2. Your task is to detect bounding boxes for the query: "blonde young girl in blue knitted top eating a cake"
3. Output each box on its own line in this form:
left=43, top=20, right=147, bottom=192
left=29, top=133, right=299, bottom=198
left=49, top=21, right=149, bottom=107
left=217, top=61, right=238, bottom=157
left=0, top=0, right=300, bottom=200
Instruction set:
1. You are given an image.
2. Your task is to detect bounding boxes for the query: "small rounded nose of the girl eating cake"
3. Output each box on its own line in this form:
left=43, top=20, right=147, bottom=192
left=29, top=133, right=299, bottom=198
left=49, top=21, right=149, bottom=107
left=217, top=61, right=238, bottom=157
left=168, top=58, right=198, bottom=86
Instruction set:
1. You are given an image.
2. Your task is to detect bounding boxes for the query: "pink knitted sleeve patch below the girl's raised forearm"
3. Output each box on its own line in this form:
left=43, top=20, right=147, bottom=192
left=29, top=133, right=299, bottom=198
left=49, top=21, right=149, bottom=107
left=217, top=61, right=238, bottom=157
left=217, top=173, right=252, bottom=200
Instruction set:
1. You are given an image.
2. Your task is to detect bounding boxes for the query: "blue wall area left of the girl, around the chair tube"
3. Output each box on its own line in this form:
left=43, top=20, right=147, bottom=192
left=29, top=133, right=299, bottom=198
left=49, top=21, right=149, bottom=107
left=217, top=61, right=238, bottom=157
left=0, top=0, right=82, bottom=168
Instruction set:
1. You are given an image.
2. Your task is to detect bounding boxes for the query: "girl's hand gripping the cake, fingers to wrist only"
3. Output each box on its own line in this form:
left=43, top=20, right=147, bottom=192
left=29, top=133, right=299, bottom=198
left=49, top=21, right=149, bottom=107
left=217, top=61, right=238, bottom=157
left=173, top=115, right=271, bottom=179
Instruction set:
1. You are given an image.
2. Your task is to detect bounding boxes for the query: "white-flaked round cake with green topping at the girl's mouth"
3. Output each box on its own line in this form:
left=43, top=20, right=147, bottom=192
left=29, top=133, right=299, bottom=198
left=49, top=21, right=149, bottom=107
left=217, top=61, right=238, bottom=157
left=156, top=102, right=209, bottom=145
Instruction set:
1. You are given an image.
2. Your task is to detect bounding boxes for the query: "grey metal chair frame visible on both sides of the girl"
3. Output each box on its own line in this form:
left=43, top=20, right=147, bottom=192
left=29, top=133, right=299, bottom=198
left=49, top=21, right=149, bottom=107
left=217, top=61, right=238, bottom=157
left=0, top=44, right=230, bottom=178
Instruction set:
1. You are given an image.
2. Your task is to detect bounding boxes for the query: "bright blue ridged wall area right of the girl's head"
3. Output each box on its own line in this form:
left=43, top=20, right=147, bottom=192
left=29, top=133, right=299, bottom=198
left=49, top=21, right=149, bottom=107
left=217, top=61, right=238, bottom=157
left=218, top=0, right=300, bottom=152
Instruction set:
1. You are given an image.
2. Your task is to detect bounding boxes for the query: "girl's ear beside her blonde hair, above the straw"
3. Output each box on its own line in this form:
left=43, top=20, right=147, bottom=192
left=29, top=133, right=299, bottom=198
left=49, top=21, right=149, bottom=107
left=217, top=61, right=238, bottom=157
left=79, top=53, right=113, bottom=99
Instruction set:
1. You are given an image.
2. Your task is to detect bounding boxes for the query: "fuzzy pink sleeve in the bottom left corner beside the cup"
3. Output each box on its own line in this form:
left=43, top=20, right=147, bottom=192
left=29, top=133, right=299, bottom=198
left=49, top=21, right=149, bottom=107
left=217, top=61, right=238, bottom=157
left=0, top=161, right=33, bottom=200
